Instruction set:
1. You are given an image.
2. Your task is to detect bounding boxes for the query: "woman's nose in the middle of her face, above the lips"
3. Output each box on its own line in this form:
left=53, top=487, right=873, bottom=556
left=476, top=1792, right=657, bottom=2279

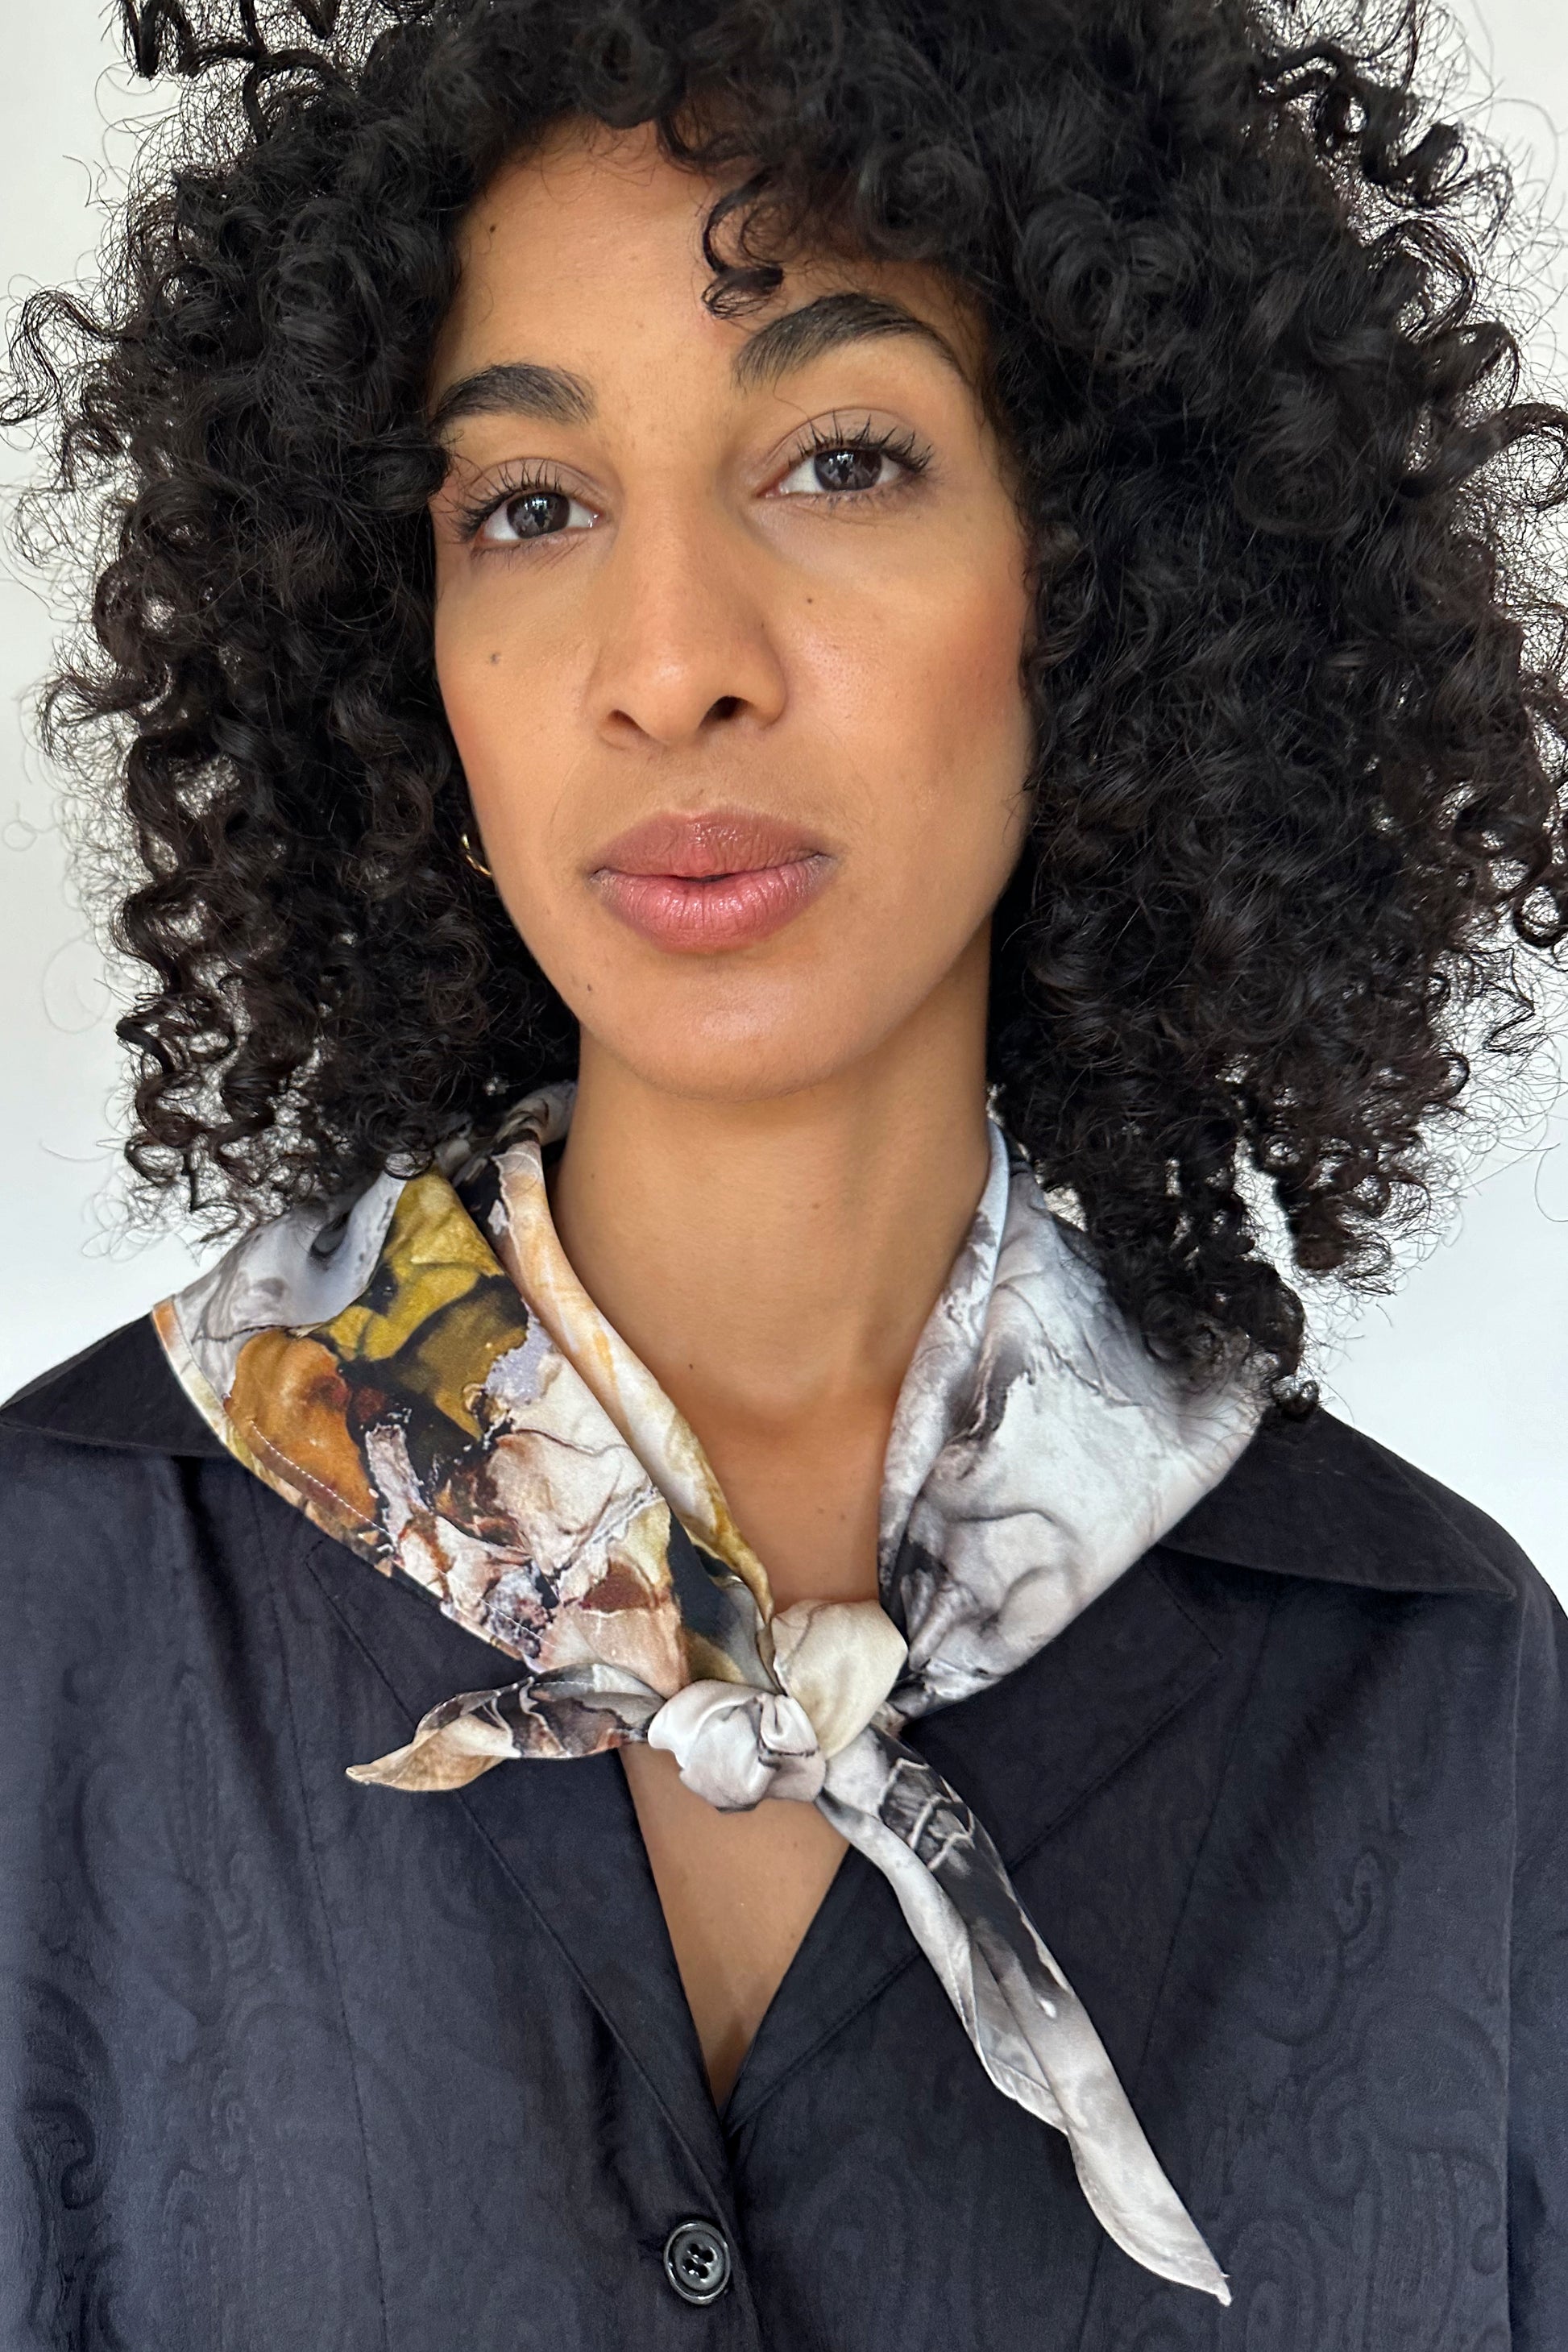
left=590, top=501, right=785, bottom=750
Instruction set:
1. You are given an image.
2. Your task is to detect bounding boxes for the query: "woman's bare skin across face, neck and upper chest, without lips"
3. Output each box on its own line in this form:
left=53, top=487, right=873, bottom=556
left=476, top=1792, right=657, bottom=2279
left=430, top=127, right=1030, bottom=2098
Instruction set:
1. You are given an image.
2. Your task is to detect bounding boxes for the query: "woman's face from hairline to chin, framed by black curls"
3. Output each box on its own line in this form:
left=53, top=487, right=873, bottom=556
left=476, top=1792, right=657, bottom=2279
left=430, top=131, right=1030, bottom=1101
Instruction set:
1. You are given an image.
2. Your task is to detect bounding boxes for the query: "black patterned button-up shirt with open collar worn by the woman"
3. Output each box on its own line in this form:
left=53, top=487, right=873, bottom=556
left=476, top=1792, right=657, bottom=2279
left=0, top=1324, right=1568, bottom=2352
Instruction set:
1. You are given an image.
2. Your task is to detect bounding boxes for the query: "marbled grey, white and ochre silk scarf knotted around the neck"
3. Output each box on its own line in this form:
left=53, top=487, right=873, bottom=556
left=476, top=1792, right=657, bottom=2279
left=156, top=1087, right=1258, bottom=2303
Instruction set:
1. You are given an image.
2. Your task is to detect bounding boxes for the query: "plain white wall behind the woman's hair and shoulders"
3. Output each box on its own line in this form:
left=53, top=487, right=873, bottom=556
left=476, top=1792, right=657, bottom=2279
left=0, top=0, right=1568, bottom=1597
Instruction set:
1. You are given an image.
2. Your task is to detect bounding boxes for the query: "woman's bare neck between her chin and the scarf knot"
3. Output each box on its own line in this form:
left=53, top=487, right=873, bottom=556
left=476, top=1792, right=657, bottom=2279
left=553, top=939, right=989, bottom=1604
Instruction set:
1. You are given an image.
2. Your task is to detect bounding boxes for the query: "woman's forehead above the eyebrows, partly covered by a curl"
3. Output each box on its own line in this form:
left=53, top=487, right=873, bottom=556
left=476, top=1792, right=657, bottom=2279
left=430, top=122, right=983, bottom=400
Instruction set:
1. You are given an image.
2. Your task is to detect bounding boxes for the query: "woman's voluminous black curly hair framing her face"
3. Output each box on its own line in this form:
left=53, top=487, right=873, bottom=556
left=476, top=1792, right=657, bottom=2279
left=10, top=0, right=1568, bottom=1402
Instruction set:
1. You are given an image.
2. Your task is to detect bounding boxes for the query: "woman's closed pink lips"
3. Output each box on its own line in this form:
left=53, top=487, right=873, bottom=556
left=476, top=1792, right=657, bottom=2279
left=590, top=809, right=835, bottom=955
